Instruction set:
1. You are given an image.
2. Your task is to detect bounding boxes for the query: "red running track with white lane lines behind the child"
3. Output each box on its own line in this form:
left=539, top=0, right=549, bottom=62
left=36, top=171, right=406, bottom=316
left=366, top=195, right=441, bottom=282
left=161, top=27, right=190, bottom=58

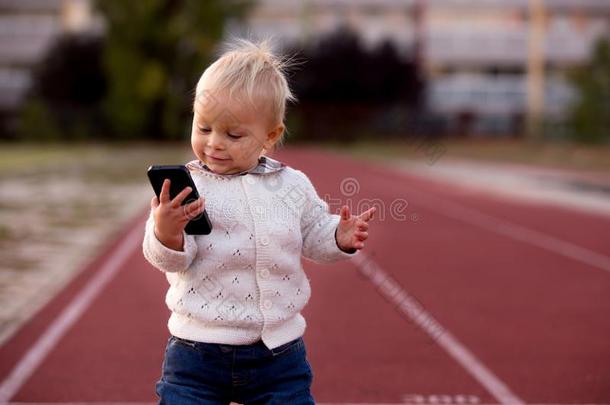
left=0, top=149, right=610, bottom=404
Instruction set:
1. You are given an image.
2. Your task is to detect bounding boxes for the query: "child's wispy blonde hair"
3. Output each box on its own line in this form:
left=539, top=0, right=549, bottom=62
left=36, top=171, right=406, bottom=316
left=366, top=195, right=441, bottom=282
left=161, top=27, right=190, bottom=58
left=195, top=38, right=296, bottom=133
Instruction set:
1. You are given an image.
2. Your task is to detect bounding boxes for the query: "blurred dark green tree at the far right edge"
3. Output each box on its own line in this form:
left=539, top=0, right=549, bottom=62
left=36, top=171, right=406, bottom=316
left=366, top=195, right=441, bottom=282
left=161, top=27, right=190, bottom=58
left=570, top=39, right=610, bottom=143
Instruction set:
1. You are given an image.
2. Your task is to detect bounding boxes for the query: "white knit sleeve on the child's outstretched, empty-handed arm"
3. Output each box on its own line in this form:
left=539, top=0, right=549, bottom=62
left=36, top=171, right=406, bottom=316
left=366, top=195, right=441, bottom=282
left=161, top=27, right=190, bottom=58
left=298, top=172, right=357, bottom=263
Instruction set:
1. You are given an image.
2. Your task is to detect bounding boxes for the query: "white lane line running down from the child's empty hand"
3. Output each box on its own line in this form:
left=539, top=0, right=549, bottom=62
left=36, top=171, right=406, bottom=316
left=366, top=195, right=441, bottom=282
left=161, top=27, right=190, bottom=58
left=351, top=251, right=525, bottom=405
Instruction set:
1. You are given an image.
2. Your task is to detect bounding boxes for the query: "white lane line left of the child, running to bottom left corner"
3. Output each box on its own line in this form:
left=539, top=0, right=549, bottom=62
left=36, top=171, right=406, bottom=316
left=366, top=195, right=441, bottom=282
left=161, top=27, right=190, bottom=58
left=0, top=226, right=143, bottom=404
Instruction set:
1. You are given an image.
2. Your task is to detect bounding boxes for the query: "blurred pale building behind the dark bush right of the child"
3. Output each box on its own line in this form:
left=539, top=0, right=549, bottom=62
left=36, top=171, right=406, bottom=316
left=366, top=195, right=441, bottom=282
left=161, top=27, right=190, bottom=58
left=242, top=0, right=610, bottom=133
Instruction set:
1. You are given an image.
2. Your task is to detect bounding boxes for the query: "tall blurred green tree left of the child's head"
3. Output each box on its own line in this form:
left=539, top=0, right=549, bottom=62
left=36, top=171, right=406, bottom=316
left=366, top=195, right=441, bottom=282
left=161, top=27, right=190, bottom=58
left=98, top=0, right=251, bottom=139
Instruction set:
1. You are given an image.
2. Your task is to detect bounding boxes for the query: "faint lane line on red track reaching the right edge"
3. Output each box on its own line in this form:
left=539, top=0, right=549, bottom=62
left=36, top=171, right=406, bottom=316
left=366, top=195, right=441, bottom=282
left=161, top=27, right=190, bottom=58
left=384, top=175, right=610, bottom=273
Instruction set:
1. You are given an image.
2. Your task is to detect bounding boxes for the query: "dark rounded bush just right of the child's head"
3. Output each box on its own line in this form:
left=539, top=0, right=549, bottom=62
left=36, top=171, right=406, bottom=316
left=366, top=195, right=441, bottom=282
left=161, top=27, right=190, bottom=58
left=289, top=28, right=422, bottom=141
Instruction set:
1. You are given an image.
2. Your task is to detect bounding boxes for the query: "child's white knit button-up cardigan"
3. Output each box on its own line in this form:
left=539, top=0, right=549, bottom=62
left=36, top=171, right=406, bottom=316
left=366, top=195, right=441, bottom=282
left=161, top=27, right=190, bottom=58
left=142, top=157, right=357, bottom=349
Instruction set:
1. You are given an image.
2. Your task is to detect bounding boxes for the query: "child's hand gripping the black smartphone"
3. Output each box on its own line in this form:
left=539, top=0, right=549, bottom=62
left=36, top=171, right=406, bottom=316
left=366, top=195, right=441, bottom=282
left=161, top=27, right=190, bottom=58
left=150, top=179, right=205, bottom=251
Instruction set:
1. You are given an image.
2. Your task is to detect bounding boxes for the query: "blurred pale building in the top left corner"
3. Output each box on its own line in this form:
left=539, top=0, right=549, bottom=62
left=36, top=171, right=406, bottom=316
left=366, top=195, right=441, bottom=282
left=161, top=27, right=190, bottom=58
left=0, top=0, right=102, bottom=114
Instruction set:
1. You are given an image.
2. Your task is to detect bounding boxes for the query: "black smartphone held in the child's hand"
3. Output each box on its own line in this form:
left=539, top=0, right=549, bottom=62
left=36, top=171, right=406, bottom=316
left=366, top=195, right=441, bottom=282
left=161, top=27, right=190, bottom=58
left=148, top=165, right=212, bottom=235
